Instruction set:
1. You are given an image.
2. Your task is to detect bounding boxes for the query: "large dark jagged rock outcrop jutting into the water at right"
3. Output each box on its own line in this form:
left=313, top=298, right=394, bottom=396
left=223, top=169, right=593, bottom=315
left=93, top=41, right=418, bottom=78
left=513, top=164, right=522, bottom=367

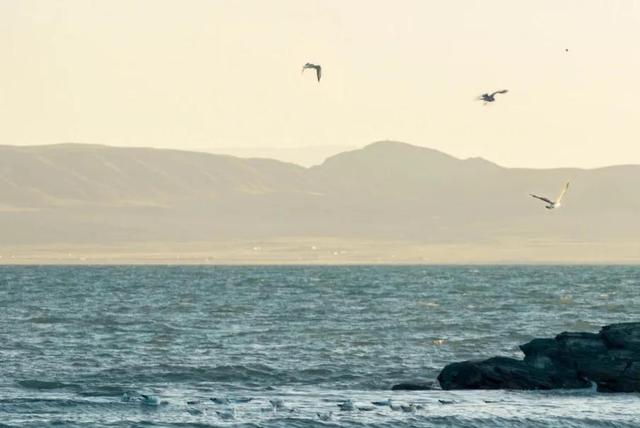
left=438, top=322, right=640, bottom=392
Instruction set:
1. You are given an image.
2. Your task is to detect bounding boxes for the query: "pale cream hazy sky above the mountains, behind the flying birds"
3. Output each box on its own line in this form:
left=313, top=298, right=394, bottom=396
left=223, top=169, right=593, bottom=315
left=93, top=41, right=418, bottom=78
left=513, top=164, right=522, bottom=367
left=0, top=0, right=640, bottom=167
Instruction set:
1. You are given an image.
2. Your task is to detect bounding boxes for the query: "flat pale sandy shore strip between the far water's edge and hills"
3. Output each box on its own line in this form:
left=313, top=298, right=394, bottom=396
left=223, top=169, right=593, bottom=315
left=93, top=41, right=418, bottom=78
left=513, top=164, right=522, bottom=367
left=0, top=237, right=640, bottom=266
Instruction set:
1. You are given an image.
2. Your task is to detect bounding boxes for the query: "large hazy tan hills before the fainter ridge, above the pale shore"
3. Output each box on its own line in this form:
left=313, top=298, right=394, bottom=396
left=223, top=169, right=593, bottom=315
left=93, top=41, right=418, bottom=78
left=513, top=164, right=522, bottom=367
left=0, top=141, right=640, bottom=260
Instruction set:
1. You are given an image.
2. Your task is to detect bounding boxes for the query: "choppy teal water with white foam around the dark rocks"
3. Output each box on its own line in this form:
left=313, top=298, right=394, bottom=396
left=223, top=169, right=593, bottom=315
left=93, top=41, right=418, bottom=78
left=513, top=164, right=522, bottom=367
left=0, top=266, right=640, bottom=427
